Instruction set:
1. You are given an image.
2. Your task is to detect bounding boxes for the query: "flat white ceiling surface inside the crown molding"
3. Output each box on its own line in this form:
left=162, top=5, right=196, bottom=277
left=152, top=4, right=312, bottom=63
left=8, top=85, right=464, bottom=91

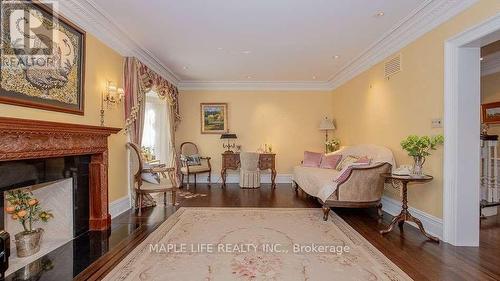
left=94, top=0, right=429, bottom=82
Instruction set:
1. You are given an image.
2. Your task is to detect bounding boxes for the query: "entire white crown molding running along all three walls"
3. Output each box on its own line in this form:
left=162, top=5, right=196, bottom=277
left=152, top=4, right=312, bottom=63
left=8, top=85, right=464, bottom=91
left=49, top=0, right=478, bottom=91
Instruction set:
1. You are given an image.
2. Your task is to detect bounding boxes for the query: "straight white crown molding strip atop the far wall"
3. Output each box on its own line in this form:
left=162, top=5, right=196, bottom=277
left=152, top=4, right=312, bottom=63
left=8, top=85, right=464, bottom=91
left=178, top=81, right=331, bottom=91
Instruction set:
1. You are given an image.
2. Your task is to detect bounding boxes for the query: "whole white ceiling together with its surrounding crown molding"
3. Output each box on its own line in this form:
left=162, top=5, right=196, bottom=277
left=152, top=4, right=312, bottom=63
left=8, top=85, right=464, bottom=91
left=56, top=0, right=479, bottom=88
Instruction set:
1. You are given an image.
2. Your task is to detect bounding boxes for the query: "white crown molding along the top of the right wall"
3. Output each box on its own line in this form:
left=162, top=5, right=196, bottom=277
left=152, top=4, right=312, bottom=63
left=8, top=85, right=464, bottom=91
left=329, top=0, right=479, bottom=90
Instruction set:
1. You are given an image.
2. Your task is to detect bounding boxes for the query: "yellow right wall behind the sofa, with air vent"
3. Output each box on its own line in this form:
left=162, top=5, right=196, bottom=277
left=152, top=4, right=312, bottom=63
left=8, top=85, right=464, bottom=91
left=332, top=0, right=500, bottom=217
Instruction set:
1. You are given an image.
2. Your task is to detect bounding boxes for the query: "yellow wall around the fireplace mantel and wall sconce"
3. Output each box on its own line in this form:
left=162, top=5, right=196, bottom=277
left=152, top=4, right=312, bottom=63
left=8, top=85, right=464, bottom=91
left=0, top=33, right=128, bottom=202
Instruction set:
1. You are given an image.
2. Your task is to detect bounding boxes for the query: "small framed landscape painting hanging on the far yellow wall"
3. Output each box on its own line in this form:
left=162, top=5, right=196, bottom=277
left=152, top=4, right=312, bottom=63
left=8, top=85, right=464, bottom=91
left=200, top=103, right=229, bottom=134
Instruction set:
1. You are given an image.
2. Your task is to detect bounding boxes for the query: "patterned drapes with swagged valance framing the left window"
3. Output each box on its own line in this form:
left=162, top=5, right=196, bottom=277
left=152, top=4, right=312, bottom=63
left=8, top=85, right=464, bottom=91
left=124, top=57, right=181, bottom=207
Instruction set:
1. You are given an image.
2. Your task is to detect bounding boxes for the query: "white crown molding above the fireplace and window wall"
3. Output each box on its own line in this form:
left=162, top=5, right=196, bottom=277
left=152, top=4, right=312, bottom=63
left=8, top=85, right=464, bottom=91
left=50, top=0, right=179, bottom=85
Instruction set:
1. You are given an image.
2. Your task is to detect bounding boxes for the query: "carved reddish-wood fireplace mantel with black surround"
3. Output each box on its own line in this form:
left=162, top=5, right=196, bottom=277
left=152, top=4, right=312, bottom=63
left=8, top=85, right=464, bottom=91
left=0, top=117, right=120, bottom=276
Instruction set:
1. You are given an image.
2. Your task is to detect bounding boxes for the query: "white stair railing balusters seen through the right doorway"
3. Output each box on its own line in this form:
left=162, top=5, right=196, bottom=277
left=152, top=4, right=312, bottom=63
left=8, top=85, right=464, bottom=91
left=479, top=132, right=500, bottom=219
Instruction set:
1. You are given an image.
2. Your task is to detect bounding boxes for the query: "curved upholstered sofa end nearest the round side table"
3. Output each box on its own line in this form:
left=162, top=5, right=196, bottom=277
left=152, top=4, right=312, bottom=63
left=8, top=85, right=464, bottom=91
left=332, top=163, right=391, bottom=202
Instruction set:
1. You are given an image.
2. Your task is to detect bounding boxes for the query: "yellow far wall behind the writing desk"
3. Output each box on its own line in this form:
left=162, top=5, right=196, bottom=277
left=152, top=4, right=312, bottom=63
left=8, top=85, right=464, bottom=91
left=176, top=91, right=332, bottom=175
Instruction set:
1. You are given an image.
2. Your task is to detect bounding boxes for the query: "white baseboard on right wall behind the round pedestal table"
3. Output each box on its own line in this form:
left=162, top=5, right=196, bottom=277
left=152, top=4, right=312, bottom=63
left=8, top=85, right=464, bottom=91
left=382, top=196, right=443, bottom=239
